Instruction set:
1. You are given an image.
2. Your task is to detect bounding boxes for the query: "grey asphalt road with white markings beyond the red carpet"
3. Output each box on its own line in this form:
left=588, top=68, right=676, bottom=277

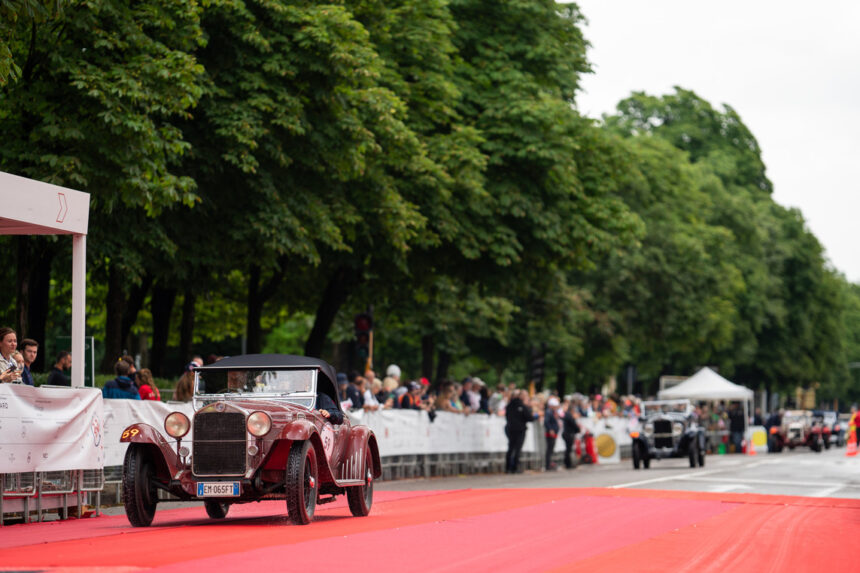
left=376, top=448, right=860, bottom=499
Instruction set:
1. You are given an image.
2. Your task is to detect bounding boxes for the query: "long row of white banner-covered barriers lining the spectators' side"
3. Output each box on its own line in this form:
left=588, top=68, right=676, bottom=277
left=0, top=384, right=630, bottom=474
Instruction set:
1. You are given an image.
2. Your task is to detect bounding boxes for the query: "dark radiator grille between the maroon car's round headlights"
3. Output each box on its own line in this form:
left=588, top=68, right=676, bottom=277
left=192, top=412, right=247, bottom=476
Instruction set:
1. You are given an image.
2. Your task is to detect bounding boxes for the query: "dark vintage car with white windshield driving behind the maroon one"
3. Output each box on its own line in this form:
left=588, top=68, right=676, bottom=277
left=630, top=400, right=708, bottom=470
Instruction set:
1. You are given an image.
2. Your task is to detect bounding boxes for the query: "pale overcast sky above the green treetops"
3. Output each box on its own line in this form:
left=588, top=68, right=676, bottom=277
left=577, top=0, right=860, bottom=283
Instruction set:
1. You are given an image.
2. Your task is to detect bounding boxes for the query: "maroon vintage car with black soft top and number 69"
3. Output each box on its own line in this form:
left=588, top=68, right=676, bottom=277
left=121, top=354, right=382, bottom=527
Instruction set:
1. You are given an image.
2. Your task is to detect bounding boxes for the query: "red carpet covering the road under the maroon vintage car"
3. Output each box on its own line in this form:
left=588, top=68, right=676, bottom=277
left=0, top=488, right=860, bottom=573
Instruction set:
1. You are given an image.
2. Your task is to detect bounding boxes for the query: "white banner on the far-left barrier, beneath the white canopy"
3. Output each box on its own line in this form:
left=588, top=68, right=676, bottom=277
left=0, top=384, right=105, bottom=473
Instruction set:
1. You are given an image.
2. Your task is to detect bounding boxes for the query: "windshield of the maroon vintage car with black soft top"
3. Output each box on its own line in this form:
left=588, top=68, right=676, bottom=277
left=194, top=368, right=317, bottom=407
